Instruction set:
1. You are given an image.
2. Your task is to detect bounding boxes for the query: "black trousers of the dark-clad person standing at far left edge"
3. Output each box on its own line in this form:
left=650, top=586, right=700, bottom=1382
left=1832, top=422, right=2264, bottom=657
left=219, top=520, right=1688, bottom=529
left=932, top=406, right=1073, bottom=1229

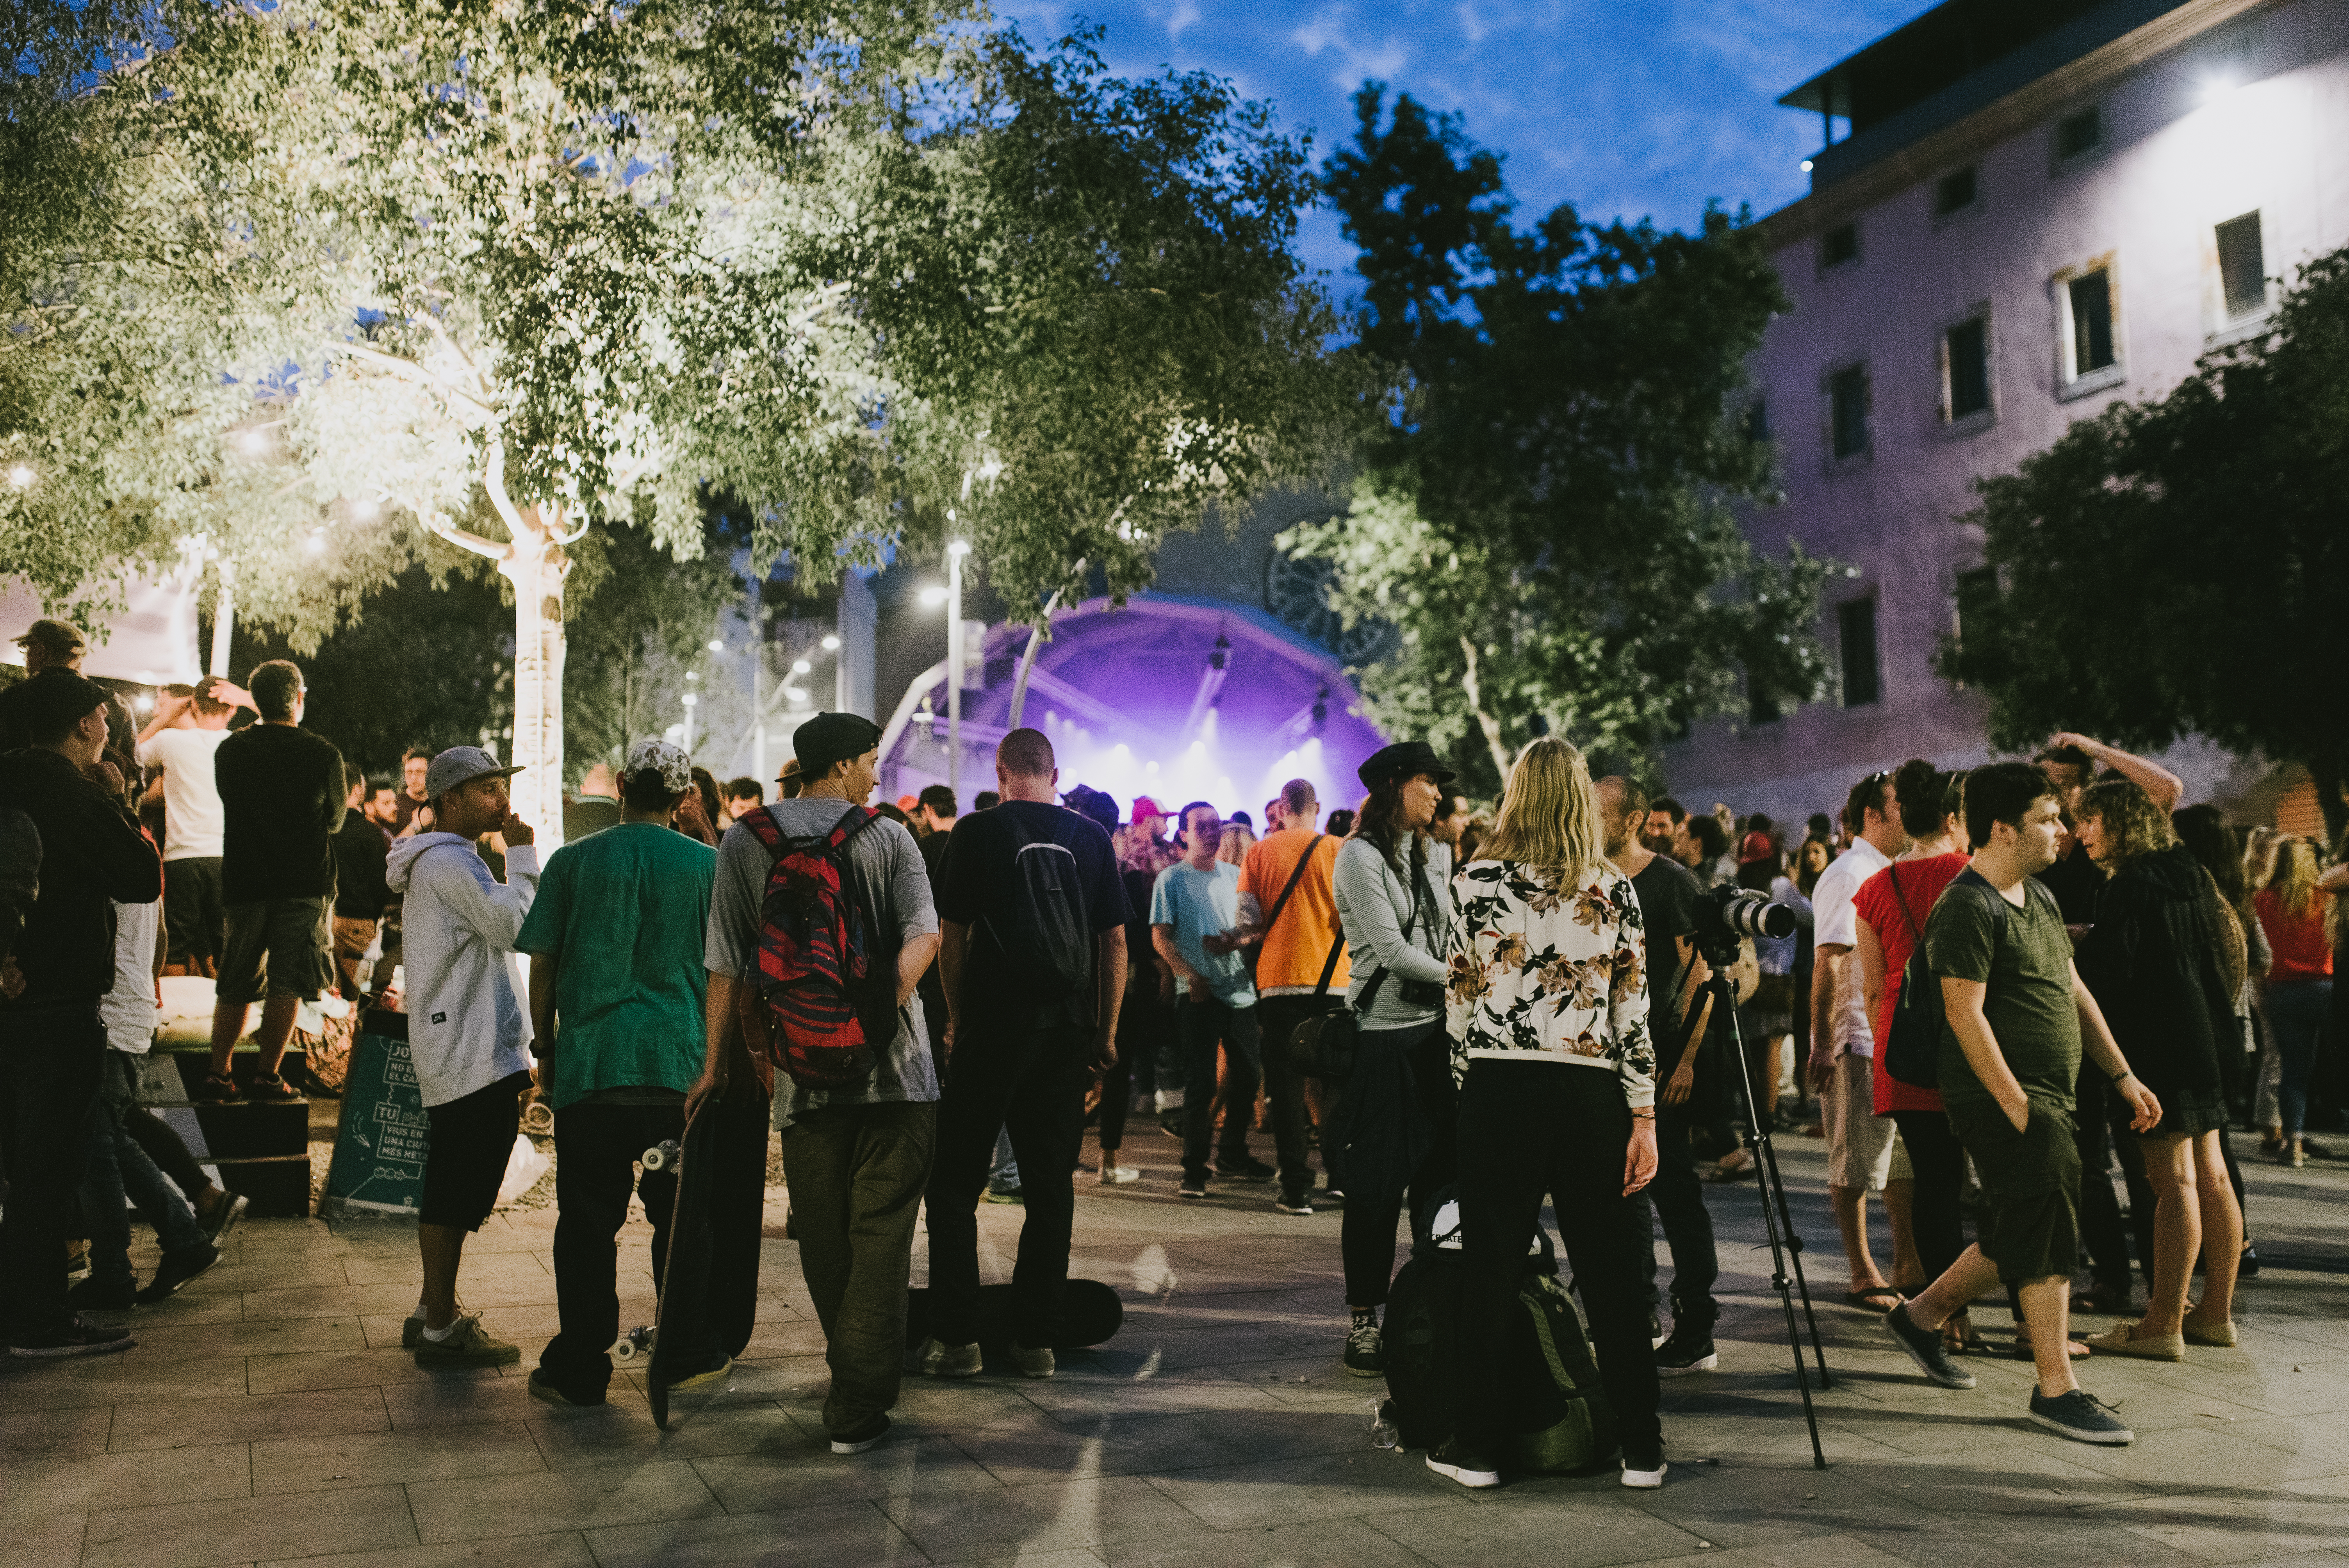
left=0, top=1000, right=106, bottom=1345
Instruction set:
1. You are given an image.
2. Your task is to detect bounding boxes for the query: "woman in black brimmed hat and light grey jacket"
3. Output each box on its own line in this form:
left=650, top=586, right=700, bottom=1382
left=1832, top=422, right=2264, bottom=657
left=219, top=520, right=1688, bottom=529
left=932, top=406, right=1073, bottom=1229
left=1330, top=739, right=1454, bottom=1378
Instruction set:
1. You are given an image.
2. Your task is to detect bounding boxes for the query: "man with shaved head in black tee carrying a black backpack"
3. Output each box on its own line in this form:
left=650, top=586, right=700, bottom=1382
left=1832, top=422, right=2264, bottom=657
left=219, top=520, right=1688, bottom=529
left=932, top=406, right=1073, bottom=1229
left=923, top=730, right=1128, bottom=1378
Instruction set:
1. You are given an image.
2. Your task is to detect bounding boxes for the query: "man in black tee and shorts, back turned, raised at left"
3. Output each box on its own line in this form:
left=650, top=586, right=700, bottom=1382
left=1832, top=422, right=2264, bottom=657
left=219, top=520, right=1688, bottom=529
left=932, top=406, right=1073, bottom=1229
left=195, top=659, right=348, bottom=1103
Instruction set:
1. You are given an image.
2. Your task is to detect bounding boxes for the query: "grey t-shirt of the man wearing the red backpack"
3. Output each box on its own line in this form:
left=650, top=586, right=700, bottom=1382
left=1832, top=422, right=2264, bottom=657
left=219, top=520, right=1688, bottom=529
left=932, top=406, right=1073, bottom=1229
left=702, top=796, right=937, bottom=1127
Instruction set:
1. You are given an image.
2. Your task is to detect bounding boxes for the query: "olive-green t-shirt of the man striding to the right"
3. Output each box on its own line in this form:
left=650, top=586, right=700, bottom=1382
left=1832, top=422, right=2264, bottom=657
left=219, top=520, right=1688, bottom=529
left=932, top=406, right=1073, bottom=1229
left=1924, top=868, right=2079, bottom=1110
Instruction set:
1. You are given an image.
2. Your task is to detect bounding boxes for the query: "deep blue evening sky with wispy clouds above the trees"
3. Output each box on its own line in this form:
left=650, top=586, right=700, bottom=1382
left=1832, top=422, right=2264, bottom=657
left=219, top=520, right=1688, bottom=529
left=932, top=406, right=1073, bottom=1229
left=996, top=0, right=1931, bottom=278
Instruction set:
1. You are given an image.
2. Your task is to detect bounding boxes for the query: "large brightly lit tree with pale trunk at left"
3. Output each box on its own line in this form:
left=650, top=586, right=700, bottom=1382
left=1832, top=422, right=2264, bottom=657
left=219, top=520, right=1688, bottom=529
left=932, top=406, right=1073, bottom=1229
left=0, top=0, right=1320, bottom=831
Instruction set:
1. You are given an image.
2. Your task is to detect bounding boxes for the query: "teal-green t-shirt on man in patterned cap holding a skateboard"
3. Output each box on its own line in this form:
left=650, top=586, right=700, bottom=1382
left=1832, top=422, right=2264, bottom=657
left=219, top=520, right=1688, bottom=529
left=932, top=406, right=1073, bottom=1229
left=515, top=821, right=719, bottom=1110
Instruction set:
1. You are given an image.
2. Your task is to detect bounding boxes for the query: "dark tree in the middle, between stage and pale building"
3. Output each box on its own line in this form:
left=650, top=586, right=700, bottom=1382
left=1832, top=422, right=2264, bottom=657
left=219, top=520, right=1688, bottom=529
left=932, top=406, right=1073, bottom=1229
left=1285, top=82, right=1825, bottom=786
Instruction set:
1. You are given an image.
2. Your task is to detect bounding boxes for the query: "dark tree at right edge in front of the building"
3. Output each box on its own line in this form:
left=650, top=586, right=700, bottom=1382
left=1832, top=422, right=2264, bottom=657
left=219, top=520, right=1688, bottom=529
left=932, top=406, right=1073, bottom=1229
left=1940, top=249, right=2349, bottom=838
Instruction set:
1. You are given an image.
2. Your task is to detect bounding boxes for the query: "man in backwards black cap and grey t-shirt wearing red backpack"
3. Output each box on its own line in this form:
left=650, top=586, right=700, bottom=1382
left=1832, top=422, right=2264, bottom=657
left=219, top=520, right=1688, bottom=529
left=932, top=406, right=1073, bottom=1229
left=686, top=714, right=937, bottom=1453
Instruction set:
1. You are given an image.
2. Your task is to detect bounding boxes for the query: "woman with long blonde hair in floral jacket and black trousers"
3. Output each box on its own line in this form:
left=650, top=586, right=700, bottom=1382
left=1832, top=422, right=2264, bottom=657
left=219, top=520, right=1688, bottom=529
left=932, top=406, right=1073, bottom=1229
left=1428, top=735, right=1663, bottom=1488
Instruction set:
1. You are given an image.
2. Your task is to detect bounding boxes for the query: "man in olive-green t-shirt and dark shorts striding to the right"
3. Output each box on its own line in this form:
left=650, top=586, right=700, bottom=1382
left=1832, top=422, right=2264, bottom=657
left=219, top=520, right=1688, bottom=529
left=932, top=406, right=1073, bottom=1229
left=1884, top=763, right=2161, bottom=1443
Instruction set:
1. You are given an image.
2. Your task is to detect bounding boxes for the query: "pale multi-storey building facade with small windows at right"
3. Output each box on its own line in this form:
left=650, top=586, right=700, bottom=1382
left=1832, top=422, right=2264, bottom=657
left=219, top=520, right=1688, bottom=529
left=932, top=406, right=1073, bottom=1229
left=1663, top=0, right=2349, bottom=819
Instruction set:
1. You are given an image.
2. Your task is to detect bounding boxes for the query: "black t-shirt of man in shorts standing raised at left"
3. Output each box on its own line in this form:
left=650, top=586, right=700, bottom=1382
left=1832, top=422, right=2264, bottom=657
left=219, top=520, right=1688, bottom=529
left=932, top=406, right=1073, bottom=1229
left=211, top=723, right=350, bottom=904
